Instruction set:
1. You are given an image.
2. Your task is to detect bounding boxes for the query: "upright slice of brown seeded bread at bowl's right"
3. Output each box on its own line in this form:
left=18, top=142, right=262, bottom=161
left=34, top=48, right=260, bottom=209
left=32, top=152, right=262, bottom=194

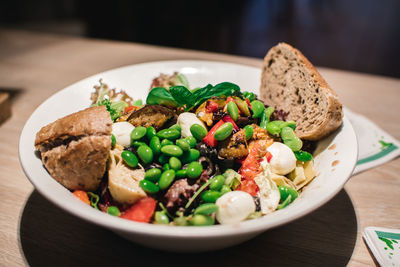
left=260, top=43, right=343, bottom=140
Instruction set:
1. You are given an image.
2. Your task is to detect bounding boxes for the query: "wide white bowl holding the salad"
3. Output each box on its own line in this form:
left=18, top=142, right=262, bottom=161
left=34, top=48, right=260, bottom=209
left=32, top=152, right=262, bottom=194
left=19, top=60, right=357, bottom=251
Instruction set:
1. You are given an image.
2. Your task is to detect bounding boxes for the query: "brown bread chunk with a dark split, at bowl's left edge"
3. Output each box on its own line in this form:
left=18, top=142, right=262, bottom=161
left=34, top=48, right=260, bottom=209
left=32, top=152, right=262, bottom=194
left=35, top=106, right=112, bottom=191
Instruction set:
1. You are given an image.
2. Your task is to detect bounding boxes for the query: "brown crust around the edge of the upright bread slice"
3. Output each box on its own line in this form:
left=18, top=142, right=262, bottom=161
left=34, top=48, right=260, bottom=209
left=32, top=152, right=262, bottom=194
left=260, top=43, right=343, bottom=141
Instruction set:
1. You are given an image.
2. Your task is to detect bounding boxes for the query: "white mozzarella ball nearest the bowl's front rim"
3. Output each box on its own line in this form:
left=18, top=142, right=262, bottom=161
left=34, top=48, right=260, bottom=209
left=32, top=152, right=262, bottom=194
left=215, top=191, right=256, bottom=224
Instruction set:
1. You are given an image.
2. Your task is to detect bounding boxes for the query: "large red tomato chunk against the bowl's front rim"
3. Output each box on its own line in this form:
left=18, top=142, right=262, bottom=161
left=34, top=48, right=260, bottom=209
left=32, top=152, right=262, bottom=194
left=120, top=197, right=156, bottom=223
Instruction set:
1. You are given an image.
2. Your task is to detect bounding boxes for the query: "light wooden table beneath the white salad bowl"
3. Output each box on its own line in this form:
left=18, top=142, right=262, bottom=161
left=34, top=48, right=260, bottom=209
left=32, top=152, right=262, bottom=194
left=0, top=29, right=400, bottom=266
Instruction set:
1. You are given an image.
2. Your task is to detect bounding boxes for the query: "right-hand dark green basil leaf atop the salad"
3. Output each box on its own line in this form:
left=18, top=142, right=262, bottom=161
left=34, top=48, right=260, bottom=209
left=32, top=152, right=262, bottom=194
left=193, top=82, right=240, bottom=106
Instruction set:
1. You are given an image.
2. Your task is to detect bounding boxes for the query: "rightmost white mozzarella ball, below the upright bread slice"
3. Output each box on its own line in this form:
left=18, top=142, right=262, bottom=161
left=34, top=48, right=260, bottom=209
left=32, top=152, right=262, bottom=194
left=264, top=142, right=296, bottom=175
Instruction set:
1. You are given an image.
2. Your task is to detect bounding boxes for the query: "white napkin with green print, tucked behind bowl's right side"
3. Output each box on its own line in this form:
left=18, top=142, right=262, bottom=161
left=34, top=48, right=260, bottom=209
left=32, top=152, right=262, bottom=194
left=344, top=108, right=400, bottom=174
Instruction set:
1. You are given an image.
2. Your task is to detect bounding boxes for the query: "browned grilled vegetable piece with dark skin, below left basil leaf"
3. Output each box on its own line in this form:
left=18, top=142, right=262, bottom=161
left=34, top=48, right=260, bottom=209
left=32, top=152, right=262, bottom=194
left=127, top=105, right=178, bottom=131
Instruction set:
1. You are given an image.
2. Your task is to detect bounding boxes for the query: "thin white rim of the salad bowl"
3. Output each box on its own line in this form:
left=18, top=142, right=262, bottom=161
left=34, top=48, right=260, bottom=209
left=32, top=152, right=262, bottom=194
left=18, top=60, right=358, bottom=239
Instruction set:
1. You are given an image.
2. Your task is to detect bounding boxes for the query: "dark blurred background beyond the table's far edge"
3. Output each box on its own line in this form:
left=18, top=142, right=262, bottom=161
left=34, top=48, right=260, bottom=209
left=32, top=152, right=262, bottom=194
left=0, top=0, right=400, bottom=78
